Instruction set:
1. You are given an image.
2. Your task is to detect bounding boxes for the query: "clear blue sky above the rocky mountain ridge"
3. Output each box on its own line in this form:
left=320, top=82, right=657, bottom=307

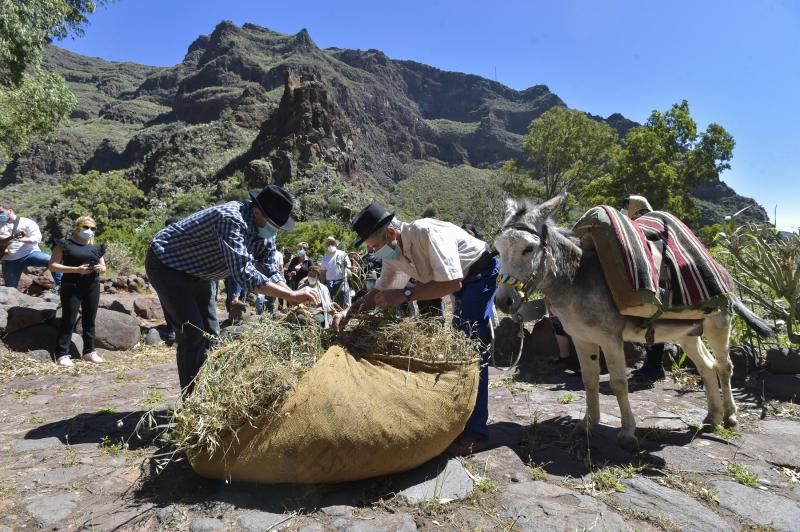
left=59, top=0, right=800, bottom=230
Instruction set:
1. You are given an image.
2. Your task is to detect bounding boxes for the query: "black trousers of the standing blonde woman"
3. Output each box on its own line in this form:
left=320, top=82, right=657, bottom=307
left=56, top=282, right=100, bottom=360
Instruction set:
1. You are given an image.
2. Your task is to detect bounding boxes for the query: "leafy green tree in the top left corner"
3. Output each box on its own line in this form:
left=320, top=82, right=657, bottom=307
left=0, top=0, right=105, bottom=161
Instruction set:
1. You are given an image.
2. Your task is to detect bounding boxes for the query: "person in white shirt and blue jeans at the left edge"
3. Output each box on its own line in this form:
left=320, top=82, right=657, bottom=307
left=0, top=205, right=61, bottom=288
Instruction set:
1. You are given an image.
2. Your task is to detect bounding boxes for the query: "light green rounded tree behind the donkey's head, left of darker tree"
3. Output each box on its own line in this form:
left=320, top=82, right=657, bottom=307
left=504, top=107, right=620, bottom=212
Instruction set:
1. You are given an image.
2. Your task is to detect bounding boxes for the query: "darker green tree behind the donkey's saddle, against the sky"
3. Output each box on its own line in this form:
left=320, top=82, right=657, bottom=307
left=609, top=100, right=735, bottom=221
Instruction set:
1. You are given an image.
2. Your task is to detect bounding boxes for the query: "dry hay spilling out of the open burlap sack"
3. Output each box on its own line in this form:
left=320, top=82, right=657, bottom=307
left=159, top=316, right=477, bottom=460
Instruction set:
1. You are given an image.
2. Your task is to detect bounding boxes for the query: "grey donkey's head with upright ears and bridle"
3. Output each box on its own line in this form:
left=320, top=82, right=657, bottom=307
left=494, top=194, right=566, bottom=312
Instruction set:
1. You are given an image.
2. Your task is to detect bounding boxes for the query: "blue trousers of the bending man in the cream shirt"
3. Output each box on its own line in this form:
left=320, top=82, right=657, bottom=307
left=453, top=257, right=500, bottom=439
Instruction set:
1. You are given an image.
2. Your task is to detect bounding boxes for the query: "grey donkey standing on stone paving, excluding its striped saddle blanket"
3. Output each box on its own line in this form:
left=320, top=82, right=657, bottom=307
left=495, top=194, right=773, bottom=450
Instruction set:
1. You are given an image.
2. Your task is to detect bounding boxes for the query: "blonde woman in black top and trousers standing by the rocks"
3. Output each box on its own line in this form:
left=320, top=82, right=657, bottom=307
left=49, top=216, right=106, bottom=366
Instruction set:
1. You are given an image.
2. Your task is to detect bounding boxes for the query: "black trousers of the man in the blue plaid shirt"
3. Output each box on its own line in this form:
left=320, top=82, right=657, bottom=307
left=145, top=250, right=219, bottom=394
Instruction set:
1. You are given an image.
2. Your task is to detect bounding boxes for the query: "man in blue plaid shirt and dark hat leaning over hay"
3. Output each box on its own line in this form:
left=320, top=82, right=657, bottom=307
left=145, top=185, right=319, bottom=393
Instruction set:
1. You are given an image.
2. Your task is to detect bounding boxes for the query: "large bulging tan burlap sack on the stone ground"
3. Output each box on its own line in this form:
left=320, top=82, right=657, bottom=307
left=190, top=347, right=479, bottom=484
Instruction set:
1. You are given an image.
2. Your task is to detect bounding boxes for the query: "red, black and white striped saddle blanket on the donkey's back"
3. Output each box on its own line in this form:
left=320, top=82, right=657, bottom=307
left=573, top=205, right=732, bottom=318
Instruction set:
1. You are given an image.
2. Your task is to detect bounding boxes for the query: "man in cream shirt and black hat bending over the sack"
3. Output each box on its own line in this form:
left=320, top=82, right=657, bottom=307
left=334, top=202, right=500, bottom=447
